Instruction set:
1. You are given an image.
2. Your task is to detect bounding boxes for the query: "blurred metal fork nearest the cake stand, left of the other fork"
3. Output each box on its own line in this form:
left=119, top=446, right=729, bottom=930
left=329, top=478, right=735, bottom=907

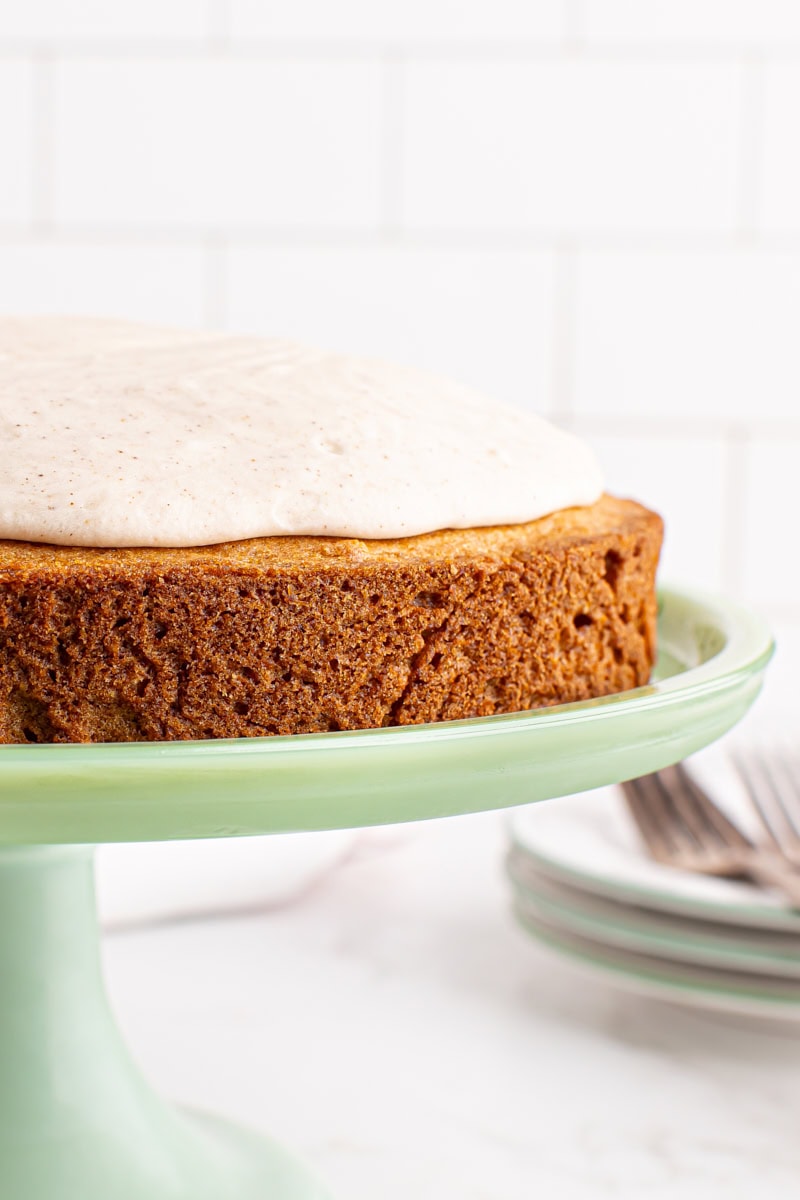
left=621, top=763, right=800, bottom=908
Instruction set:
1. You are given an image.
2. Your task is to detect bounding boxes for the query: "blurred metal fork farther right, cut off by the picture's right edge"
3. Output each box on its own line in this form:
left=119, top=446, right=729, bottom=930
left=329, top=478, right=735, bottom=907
left=732, top=750, right=800, bottom=869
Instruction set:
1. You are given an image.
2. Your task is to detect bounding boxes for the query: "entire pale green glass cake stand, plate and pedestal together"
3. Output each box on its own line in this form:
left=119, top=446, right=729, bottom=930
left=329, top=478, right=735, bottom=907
left=0, top=590, right=772, bottom=1200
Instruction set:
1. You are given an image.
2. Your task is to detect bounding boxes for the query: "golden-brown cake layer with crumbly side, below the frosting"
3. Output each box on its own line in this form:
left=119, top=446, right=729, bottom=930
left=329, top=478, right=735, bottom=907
left=0, top=496, right=662, bottom=743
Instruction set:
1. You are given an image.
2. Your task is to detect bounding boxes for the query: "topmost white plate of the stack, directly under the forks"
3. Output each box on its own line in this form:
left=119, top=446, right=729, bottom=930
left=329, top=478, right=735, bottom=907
left=510, top=751, right=800, bottom=932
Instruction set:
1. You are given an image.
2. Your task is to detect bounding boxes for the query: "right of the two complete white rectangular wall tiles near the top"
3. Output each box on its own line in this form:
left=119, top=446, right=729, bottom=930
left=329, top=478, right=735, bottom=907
left=402, top=59, right=741, bottom=234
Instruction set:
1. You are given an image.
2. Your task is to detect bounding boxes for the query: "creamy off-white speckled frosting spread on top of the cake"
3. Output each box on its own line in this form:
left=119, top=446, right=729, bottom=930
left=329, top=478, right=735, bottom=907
left=0, top=317, right=602, bottom=547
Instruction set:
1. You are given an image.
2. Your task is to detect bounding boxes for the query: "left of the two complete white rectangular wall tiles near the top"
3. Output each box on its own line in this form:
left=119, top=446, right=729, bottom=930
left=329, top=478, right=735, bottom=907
left=53, top=58, right=381, bottom=230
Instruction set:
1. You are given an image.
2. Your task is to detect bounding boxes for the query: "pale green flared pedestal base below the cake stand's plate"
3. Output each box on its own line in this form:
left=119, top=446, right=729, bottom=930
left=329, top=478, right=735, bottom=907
left=0, top=846, right=327, bottom=1200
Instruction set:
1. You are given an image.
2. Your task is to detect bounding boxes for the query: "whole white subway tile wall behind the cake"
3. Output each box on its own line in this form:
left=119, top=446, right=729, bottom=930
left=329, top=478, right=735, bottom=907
left=0, top=7, right=800, bottom=657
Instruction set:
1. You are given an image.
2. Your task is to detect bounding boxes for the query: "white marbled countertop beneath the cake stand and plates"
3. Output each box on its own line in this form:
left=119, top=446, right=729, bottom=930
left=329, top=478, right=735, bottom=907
left=100, top=796, right=800, bottom=1200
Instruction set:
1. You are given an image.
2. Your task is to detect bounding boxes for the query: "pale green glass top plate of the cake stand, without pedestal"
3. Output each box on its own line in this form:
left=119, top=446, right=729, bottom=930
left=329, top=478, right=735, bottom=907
left=0, top=589, right=772, bottom=844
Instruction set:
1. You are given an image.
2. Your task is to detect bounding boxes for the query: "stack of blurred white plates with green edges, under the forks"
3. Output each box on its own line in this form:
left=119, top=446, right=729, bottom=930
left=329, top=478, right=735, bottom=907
left=507, top=753, right=800, bottom=1020
